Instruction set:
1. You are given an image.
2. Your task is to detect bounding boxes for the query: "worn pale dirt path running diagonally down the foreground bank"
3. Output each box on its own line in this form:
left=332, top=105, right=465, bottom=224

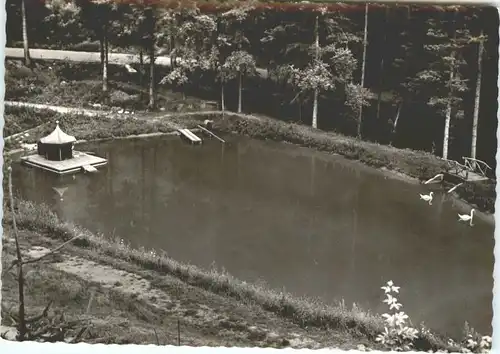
left=4, top=239, right=368, bottom=349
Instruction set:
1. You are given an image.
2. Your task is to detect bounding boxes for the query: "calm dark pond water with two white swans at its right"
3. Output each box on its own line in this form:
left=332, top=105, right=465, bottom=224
left=10, top=137, right=494, bottom=336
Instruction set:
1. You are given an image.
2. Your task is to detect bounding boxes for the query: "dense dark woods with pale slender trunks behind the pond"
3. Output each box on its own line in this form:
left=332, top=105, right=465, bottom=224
left=6, top=0, right=498, bottom=171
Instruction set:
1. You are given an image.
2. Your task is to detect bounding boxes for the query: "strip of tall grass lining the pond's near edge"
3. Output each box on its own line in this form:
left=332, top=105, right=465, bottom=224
left=6, top=201, right=464, bottom=350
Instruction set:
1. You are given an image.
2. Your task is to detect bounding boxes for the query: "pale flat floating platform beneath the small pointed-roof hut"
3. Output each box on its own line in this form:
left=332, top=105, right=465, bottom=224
left=21, top=151, right=108, bottom=175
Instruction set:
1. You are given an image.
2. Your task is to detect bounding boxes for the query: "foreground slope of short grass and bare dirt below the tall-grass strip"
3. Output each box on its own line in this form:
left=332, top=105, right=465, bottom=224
left=2, top=226, right=360, bottom=349
